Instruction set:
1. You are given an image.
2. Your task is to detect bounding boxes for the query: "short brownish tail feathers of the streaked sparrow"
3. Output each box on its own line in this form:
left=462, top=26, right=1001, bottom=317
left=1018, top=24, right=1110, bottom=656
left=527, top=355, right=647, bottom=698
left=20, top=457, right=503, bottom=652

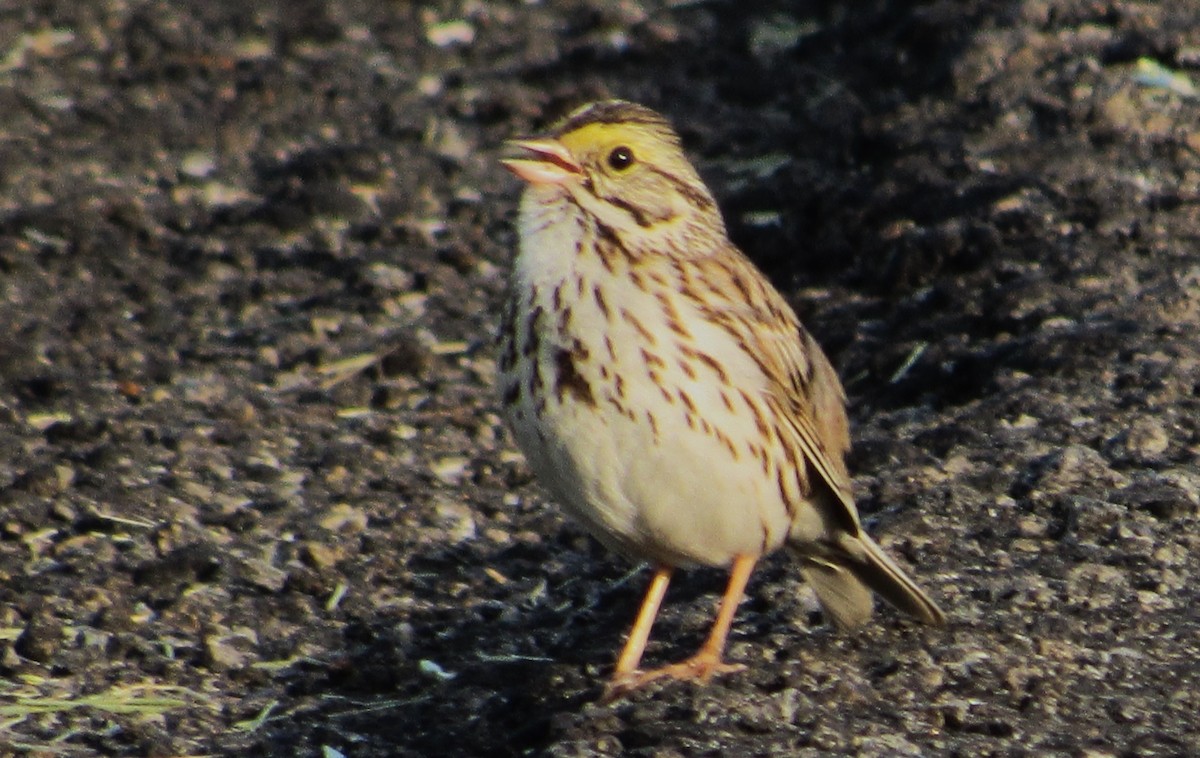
left=800, top=534, right=946, bottom=628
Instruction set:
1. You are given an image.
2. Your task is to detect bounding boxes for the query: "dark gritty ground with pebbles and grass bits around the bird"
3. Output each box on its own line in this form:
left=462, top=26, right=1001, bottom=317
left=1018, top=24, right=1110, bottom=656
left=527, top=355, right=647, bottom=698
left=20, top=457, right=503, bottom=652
left=0, top=0, right=1200, bottom=758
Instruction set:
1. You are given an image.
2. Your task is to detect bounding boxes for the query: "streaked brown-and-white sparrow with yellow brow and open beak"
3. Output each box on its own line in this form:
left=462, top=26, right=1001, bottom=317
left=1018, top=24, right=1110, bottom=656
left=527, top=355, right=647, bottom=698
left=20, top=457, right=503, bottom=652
left=497, top=100, right=946, bottom=700
